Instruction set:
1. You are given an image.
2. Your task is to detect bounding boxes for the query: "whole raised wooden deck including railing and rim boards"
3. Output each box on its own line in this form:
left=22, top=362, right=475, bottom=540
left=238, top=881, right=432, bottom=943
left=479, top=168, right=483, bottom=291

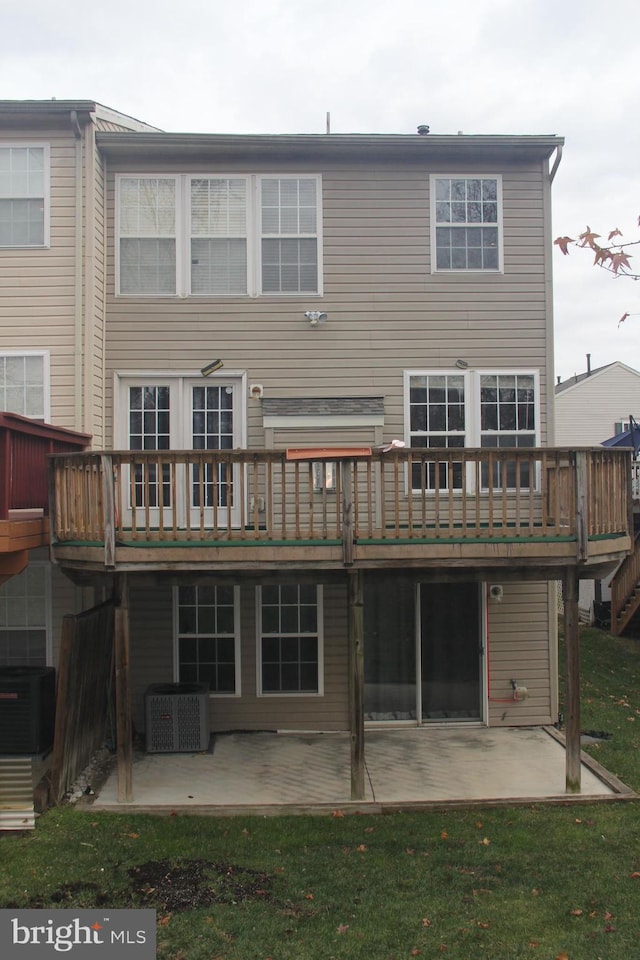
left=50, top=448, right=632, bottom=579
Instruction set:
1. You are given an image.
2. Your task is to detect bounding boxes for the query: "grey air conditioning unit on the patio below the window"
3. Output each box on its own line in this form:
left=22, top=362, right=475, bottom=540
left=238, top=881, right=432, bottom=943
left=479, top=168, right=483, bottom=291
left=145, top=683, right=209, bottom=753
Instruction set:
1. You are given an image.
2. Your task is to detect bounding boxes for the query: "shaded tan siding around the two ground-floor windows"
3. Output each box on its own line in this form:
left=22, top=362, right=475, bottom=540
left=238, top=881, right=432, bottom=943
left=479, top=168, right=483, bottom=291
left=130, top=577, right=348, bottom=731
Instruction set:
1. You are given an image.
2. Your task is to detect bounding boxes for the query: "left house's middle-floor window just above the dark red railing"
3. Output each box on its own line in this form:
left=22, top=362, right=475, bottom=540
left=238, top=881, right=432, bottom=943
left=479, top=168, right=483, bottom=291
left=0, top=353, right=49, bottom=420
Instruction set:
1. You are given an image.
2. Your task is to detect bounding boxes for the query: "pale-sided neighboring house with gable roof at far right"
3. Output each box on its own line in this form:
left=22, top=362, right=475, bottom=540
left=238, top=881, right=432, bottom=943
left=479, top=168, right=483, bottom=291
left=555, top=364, right=640, bottom=621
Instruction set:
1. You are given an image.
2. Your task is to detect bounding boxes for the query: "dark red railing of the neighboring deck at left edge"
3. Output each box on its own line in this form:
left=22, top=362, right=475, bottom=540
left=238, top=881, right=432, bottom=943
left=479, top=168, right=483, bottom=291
left=0, top=413, right=91, bottom=520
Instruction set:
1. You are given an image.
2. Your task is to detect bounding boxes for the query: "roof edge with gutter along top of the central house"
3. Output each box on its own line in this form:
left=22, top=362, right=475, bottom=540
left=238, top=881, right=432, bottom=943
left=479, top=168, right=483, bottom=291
left=96, top=131, right=564, bottom=162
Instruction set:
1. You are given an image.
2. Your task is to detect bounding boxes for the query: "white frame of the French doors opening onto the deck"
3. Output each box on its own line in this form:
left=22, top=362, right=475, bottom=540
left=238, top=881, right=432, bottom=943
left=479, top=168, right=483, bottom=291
left=113, top=370, right=247, bottom=526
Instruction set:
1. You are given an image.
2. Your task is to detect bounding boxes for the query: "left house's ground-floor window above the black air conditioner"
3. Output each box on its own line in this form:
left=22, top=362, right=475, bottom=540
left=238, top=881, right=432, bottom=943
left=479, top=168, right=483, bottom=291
left=0, top=562, right=51, bottom=667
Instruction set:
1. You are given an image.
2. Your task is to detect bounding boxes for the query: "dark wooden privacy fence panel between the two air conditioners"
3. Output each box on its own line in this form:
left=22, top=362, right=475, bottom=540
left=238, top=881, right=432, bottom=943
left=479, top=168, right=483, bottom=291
left=51, top=601, right=114, bottom=803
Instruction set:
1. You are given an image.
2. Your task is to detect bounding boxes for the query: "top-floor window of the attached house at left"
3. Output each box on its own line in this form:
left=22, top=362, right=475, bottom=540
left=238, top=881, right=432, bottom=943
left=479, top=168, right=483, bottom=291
left=0, top=144, right=49, bottom=247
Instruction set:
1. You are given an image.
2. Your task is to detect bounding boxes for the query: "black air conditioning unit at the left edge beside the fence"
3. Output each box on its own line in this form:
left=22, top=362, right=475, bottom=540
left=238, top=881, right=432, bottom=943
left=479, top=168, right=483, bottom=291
left=0, top=667, right=56, bottom=754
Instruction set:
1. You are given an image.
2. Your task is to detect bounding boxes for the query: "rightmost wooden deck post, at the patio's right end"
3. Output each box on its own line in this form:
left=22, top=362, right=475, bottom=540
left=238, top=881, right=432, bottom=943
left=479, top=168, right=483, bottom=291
left=563, top=567, right=581, bottom=793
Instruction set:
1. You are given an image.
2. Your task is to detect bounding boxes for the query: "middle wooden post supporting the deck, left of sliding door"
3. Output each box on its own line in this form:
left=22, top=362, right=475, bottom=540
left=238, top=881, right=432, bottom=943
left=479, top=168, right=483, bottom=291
left=347, top=570, right=364, bottom=800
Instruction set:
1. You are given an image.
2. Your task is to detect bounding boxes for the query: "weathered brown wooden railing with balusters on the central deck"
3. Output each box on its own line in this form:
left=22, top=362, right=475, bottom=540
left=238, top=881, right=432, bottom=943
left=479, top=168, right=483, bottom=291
left=52, top=448, right=630, bottom=561
